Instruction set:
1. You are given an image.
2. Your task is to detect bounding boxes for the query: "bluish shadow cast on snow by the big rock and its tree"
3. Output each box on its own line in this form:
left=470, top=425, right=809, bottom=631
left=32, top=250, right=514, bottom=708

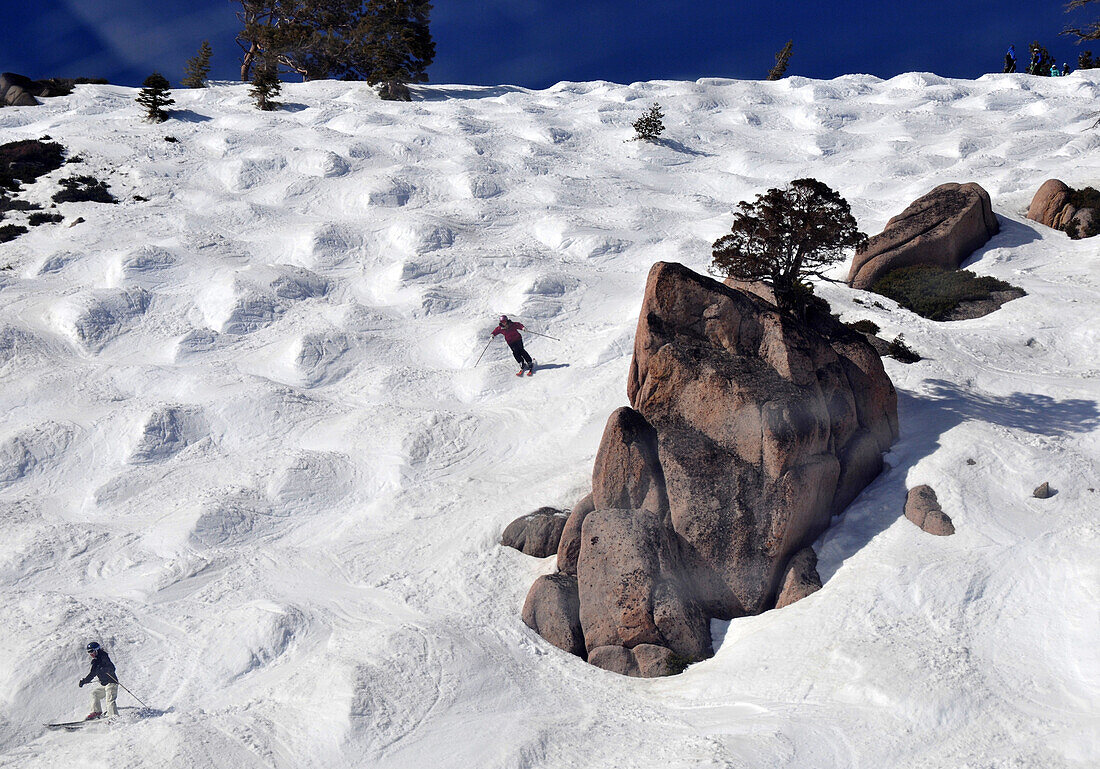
left=816, top=380, right=1100, bottom=585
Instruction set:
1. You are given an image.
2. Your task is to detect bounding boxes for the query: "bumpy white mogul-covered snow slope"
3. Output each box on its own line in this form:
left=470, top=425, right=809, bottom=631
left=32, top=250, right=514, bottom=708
left=0, top=73, right=1100, bottom=769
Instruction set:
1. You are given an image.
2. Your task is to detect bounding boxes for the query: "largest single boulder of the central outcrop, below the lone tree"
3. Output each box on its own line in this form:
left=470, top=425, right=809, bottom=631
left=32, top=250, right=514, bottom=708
left=633, top=263, right=898, bottom=618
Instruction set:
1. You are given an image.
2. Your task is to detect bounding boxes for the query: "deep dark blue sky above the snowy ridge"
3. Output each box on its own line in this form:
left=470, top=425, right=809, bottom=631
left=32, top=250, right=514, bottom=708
left=0, top=0, right=1100, bottom=88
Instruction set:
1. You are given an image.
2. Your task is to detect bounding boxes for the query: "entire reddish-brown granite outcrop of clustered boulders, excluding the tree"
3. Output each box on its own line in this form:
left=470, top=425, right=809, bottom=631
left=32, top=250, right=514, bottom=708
left=519, top=263, right=898, bottom=675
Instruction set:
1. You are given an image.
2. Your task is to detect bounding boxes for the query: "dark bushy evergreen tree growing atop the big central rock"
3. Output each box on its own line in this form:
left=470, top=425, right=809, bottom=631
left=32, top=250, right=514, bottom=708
left=712, top=179, right=867, bottom=317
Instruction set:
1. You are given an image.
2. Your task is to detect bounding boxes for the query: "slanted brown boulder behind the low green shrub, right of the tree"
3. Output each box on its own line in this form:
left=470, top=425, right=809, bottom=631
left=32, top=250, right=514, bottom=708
left=848, top=183, right=1000, bottom=289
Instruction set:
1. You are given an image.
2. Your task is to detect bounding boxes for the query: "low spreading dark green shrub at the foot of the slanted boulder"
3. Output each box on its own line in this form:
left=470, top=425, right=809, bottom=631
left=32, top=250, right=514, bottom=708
left=871, top=265, right=1012, bottom=320
